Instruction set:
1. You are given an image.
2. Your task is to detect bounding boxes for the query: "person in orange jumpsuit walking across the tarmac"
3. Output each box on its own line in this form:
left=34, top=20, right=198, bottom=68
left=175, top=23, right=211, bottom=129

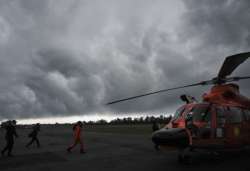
left=67, top=121, right=85, bottom=153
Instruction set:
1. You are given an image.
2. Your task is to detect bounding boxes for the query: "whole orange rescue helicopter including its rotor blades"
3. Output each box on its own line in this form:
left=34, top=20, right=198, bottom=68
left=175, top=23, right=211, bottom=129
left=107, top=52, right=250, bottom=162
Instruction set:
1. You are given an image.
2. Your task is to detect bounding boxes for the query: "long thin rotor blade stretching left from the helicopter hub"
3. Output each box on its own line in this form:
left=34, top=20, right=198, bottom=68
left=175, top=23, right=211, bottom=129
left=106, top=80, right=207, bottom=105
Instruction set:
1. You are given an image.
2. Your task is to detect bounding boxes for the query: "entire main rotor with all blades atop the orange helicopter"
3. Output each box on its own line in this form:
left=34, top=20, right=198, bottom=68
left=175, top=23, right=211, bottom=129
left=106, top=52, right=250, bottom=105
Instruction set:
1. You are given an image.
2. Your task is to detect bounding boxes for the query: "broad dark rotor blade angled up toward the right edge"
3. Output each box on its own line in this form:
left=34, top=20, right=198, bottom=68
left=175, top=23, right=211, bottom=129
left=218, top=52, right=250, bottom=78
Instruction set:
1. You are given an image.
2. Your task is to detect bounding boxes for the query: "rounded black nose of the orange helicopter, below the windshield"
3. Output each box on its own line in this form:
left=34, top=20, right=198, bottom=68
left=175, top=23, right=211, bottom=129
left=152, top=128, right=189, bottom=148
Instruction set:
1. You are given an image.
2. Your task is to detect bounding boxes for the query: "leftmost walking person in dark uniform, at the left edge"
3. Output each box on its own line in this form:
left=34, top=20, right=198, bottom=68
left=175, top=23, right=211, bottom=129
left=1, top=120, right=18, bottom=157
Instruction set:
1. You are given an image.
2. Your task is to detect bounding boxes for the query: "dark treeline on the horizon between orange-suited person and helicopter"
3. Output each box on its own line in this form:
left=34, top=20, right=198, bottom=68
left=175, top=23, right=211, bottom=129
left=83, top=115, right=172, bottom=125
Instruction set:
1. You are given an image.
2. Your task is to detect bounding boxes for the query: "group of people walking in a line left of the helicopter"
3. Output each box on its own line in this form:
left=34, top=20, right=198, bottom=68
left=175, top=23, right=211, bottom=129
left=1, top=120, right=85, bottom=157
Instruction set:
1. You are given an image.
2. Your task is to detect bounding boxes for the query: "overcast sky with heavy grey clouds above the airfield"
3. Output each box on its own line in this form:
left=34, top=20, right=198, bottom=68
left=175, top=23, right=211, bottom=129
left=0, top=0, right=250, bottom=120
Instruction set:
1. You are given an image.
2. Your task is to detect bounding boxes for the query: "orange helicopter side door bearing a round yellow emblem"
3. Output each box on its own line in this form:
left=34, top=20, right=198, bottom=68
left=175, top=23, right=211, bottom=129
left=225, top=107, right=243, bottom=146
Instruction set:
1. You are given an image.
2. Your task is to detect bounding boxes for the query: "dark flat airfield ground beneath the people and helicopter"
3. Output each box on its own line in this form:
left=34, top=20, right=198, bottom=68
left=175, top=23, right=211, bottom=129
left=0, top=125, right=250, bottom=171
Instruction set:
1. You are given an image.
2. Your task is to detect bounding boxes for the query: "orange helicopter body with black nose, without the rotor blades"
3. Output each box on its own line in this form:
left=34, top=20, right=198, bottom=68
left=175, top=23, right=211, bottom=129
left=152, top=84, right=250, bottom=151
